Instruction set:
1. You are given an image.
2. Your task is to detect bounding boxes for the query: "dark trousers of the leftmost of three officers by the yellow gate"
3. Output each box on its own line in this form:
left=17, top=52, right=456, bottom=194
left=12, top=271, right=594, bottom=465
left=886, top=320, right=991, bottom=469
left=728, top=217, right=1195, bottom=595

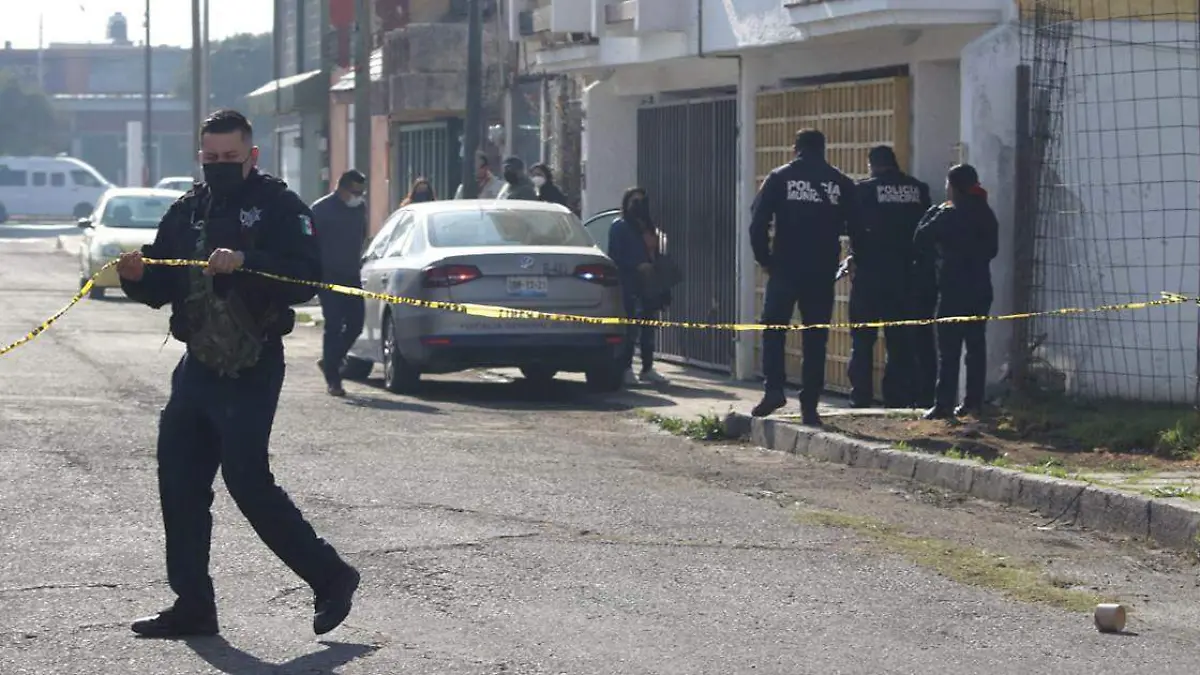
left=762, top=271, right=834, bottom=411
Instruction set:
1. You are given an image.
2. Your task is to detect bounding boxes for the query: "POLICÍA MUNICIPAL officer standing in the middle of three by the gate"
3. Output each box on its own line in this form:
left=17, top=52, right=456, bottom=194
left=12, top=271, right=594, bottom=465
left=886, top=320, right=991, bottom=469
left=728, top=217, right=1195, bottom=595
left=848, top=145, right=932, bottom=408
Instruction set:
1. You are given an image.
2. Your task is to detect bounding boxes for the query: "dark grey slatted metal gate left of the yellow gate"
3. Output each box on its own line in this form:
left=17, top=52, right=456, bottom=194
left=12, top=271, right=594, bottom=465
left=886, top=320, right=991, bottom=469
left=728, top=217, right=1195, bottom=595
left=637, top=98, right=738, bottom=370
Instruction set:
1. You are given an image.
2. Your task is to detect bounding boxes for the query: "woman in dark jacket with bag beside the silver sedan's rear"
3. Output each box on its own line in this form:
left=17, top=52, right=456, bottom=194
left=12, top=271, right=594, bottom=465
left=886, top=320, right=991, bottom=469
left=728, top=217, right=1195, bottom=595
left=608, top=187, right=667, bottom=384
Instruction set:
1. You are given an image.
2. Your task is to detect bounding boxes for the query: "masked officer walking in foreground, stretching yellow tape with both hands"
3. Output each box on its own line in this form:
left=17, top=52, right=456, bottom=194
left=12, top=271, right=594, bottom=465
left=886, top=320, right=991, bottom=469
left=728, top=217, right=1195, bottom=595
left=116, top=110, right=359, bottom=638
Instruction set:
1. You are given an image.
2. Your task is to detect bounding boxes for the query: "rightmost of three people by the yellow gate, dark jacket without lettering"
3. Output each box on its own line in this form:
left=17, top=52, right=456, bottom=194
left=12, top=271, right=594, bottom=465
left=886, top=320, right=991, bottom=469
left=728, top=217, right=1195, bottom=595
left=913, top=165, right=1000, bottom=419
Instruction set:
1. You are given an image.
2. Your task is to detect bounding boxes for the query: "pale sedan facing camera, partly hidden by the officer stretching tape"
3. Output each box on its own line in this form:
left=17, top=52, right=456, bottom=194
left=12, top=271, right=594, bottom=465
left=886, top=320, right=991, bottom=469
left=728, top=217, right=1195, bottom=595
left=79, top=187, right=184, bottom=299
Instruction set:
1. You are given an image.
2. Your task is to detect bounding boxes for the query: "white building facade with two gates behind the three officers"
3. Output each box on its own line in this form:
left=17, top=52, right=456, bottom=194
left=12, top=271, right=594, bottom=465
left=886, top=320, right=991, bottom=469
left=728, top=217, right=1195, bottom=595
left=509, top=0, right=1200, bottom=398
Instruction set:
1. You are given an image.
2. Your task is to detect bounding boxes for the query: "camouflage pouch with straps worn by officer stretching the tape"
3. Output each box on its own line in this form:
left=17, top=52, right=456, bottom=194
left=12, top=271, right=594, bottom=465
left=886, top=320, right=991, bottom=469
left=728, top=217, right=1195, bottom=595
left=184, top=198, right=270, bottom=377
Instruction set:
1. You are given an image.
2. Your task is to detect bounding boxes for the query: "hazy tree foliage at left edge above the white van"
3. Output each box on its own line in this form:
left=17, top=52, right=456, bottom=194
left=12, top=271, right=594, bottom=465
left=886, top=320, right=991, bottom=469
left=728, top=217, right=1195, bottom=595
left=0, top=70, right=66, bottom=156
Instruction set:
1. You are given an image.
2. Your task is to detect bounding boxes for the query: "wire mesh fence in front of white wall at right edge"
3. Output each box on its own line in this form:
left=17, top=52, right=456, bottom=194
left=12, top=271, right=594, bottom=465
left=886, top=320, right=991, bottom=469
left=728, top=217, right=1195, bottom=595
left=1016, top=0, right=1200, bottom=402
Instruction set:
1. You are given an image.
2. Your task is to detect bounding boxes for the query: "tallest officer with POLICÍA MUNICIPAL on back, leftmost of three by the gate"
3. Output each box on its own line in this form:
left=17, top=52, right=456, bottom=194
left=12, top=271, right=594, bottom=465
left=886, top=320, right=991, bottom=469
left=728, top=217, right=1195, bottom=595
left=750, top=129, right=854, bottom=426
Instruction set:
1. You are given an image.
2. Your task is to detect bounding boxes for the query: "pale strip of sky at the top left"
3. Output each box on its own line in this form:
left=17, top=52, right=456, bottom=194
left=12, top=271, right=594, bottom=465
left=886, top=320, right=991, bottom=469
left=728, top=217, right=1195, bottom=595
left=0, top=0, right=274, bottom=48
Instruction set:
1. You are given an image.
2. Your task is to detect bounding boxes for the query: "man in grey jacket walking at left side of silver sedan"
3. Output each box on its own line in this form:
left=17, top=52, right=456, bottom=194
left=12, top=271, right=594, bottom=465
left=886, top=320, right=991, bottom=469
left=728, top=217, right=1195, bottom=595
left=312, top=169, right=367, bottom=396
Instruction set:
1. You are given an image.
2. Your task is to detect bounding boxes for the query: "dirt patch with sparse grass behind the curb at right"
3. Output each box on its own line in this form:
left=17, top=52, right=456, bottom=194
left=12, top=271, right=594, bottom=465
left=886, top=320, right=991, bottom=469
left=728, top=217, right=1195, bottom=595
left=826, top=398, right=1200, bottom=473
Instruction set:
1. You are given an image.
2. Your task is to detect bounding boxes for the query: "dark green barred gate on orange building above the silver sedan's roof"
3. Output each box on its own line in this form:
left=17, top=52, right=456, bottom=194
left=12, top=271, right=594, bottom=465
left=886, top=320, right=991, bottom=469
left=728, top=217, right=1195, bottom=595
left=391, top=119, right=462, bottom=203
